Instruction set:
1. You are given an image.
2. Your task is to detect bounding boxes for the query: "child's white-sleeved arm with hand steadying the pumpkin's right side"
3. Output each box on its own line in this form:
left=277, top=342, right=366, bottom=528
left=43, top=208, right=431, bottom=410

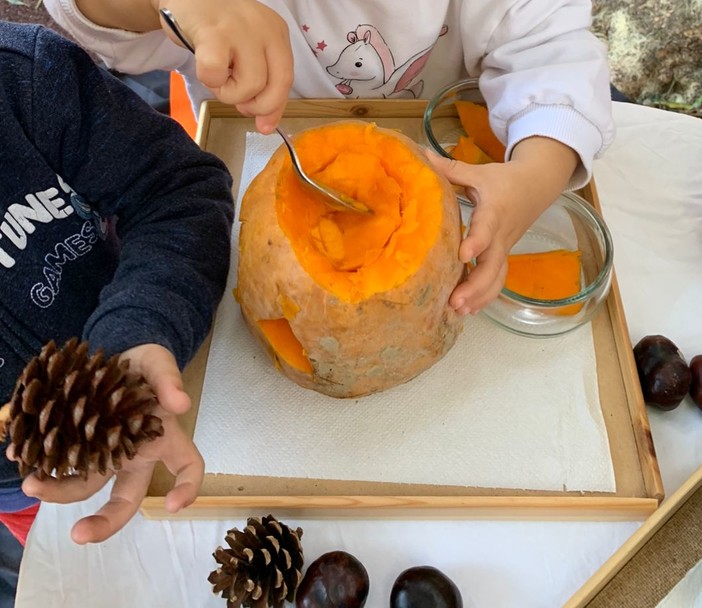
left=452, top=0, right=614, bottom=313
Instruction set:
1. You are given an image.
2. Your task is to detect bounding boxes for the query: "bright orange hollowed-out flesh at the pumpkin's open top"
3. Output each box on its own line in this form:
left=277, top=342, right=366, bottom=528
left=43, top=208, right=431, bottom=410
left=276, top=123, right=444, bottom=302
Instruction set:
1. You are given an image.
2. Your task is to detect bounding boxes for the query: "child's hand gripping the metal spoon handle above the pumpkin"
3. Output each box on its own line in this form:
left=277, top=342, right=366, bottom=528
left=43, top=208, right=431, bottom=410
left=157, top=0, right=294, bottom=134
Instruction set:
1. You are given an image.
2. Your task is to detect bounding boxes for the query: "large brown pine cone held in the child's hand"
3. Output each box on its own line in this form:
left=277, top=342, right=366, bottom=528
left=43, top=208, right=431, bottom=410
left=5, top=338, right=163, bottom=479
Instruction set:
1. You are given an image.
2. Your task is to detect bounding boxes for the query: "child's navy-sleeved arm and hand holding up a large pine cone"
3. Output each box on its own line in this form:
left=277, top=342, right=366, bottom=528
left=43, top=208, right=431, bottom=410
left=15, top=30, right=233, bottom=542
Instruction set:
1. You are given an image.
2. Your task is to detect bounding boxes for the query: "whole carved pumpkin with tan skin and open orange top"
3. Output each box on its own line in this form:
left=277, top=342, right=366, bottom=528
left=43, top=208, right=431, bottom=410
left=235, top=121, right=465, bottom=398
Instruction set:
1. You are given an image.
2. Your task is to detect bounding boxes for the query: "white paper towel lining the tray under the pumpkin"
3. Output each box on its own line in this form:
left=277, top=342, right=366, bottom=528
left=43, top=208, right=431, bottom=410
left=195, top=133, right=616, bottom=492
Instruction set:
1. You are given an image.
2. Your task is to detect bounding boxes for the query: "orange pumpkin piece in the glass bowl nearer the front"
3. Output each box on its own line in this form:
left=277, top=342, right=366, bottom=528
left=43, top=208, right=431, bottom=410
left=505, top=249, right=582, bottom=315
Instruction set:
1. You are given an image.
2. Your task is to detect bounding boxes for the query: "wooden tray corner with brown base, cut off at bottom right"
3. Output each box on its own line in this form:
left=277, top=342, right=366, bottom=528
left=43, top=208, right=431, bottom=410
left=564, top=467, right=702, bottom=608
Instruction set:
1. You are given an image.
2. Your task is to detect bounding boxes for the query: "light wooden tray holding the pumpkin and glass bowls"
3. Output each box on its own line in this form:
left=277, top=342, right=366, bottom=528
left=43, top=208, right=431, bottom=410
left=141, top=100, right=663, bottom=520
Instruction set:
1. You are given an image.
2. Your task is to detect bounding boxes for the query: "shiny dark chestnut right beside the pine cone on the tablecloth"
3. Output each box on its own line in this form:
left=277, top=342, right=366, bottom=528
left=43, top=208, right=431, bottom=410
left=295, top=551, right=370, bottom=608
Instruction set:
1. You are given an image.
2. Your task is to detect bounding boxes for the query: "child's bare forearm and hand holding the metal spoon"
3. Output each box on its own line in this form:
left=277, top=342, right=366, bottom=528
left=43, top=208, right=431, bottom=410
left=47, top=0, right=293, bottom=133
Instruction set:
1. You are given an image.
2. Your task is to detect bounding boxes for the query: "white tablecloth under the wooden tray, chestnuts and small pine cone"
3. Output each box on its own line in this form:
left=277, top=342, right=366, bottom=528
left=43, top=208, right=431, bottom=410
left=17, top=103, right=702, bottom=608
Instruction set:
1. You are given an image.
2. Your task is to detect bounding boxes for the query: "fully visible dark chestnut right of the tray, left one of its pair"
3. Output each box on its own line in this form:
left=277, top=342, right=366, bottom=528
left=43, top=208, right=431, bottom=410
left=634, top=335, right=692, bottom=410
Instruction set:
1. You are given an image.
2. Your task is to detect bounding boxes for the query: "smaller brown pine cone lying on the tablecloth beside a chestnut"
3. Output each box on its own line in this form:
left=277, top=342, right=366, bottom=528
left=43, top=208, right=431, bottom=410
left=207, top=515, right=304, bottom=608
